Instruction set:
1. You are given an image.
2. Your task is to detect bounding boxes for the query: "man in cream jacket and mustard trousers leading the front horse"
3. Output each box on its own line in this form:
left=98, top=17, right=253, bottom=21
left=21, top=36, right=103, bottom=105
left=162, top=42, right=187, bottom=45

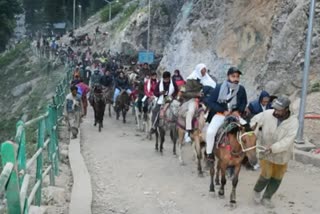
left=251, top=96, right=298, bottom=208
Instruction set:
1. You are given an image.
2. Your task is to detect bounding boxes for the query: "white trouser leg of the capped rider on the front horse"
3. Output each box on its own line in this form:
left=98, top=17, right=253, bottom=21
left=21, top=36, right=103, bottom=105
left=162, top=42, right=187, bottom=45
left=206, top=113, right=225, bottom=154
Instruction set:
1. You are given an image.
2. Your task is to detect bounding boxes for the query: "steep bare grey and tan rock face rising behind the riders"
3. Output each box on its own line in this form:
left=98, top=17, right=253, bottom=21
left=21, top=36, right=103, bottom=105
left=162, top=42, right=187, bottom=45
left=104, top=0, right=320, bottom=100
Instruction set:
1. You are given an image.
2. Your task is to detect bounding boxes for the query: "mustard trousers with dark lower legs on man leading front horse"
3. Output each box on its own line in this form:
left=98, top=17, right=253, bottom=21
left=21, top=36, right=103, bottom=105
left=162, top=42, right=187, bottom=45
left=254, top=160, right=288, bottom=199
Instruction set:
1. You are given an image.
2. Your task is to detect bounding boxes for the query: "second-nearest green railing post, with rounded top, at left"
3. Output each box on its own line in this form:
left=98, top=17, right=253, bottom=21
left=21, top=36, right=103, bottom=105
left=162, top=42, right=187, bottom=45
left=15, top=120, right=27, bottom=187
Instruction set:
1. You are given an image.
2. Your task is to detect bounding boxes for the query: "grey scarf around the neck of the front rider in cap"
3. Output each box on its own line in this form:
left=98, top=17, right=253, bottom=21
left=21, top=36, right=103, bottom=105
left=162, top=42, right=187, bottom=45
left=218, top=80, right=239, bottom=110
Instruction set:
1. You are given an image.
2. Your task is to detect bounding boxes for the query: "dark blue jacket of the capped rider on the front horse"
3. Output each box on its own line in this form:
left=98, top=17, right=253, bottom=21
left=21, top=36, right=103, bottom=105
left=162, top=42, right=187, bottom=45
left=206, top=84, right=248, bottom=115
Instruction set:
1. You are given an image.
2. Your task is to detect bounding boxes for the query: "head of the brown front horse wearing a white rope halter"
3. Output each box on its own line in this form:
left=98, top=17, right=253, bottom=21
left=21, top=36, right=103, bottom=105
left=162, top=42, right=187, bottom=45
left=238, top=124, right=258, bottom=166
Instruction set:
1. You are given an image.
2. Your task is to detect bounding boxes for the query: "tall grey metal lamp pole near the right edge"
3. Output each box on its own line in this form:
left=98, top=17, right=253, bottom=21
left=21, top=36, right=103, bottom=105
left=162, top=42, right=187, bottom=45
left=295, top=0, right=316, bottom=144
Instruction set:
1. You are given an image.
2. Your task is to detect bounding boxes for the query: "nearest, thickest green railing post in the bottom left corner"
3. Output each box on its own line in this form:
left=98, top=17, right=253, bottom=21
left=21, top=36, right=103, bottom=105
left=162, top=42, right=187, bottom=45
left=1, top=141, right=22, bottom=214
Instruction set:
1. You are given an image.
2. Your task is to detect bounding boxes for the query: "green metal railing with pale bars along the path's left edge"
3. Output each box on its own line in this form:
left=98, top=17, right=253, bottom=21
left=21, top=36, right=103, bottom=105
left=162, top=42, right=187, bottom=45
left=0, top=66, right=72, bottom=214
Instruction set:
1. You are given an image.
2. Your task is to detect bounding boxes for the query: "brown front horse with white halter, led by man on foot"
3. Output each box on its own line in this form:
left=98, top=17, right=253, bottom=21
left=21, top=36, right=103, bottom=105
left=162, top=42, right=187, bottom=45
left=210, top=116, right=258, bottom=205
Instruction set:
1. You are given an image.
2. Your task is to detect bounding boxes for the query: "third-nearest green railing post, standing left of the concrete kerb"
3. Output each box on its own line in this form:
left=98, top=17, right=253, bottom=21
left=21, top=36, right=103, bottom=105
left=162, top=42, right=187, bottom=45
left=35, top=119, right=46, bottom=206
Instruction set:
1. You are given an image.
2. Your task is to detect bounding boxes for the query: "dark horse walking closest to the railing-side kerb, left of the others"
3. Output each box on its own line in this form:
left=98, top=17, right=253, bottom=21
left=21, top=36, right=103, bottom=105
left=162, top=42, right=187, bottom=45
left=89, top=86, right=106, bottom=132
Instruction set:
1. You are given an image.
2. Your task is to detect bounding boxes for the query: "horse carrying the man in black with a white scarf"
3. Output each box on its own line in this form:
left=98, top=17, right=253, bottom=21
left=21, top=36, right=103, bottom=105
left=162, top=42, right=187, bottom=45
left=155, top=97, right=180, bottom=155
